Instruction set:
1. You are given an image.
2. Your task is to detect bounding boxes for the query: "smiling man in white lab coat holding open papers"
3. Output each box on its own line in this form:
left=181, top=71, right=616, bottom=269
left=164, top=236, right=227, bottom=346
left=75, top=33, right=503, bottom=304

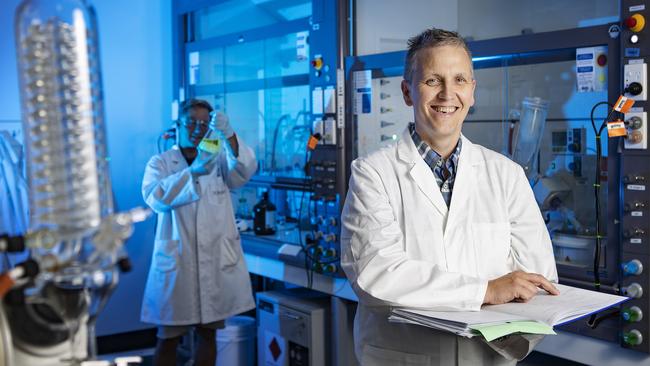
left=341, top=29, right=559, bottom=366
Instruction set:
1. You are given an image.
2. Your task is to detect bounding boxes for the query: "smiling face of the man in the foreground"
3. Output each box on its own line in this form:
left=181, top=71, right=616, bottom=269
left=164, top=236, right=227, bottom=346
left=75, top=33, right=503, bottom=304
left=402, top=45, right=476, bottom=139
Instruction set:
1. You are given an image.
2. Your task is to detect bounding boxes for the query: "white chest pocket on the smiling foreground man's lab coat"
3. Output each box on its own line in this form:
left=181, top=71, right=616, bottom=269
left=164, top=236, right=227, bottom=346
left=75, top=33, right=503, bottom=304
left=472, top=222, right=511, bottom=279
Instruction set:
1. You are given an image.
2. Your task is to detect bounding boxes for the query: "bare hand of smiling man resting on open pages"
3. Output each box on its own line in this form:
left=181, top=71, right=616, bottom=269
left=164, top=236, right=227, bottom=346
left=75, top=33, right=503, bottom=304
left=483, top=271, right=560, bottom=305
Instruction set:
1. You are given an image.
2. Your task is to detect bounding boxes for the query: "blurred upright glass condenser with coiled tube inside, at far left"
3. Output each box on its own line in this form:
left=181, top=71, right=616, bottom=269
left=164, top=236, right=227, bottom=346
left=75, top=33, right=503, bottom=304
left=15, top=0, right=112, bottom=241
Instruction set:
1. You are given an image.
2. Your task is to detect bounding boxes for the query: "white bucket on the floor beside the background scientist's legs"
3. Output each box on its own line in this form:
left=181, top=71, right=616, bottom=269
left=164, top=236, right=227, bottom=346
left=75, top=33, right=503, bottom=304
left=217, top=316, right=257, bottom=366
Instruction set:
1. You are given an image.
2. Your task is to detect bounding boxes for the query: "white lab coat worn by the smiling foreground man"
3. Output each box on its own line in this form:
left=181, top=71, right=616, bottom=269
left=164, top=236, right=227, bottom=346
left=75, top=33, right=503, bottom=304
left=341, top=129, right=557, bottom=366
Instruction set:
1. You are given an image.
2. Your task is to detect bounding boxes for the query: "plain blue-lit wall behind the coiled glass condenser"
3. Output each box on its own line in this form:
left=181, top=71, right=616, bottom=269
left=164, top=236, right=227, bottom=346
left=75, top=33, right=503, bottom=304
left=0, top=0, right=172, bottom=335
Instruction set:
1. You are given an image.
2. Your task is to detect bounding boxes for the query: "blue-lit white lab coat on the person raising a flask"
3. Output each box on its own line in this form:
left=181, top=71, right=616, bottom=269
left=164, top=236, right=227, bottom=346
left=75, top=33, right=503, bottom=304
left=141, top=139, right=257, bottom=325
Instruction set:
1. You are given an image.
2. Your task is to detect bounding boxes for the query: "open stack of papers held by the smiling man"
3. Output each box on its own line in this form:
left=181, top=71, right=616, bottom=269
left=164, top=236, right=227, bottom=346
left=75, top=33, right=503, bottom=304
left=389, top=285, right=628, bottom=342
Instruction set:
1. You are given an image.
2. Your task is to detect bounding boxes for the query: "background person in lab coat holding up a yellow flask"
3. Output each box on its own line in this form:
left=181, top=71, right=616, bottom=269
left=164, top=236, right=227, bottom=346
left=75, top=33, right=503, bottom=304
left=141, top=100, right=257, bottom=366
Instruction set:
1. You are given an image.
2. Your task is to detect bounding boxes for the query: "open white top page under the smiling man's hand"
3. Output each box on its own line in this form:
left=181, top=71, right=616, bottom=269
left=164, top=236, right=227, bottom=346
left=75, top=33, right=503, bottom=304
left=481, top=284, right=627, bottom=326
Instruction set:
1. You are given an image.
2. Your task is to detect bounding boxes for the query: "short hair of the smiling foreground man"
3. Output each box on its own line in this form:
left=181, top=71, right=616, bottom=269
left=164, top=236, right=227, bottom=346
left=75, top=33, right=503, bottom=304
left=404, top=28, right=472, bottom=82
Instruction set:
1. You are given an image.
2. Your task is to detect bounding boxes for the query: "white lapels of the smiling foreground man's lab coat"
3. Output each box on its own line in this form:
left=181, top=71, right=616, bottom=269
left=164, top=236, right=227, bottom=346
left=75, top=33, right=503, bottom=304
left=397, top=127, right=479, bottom=228
